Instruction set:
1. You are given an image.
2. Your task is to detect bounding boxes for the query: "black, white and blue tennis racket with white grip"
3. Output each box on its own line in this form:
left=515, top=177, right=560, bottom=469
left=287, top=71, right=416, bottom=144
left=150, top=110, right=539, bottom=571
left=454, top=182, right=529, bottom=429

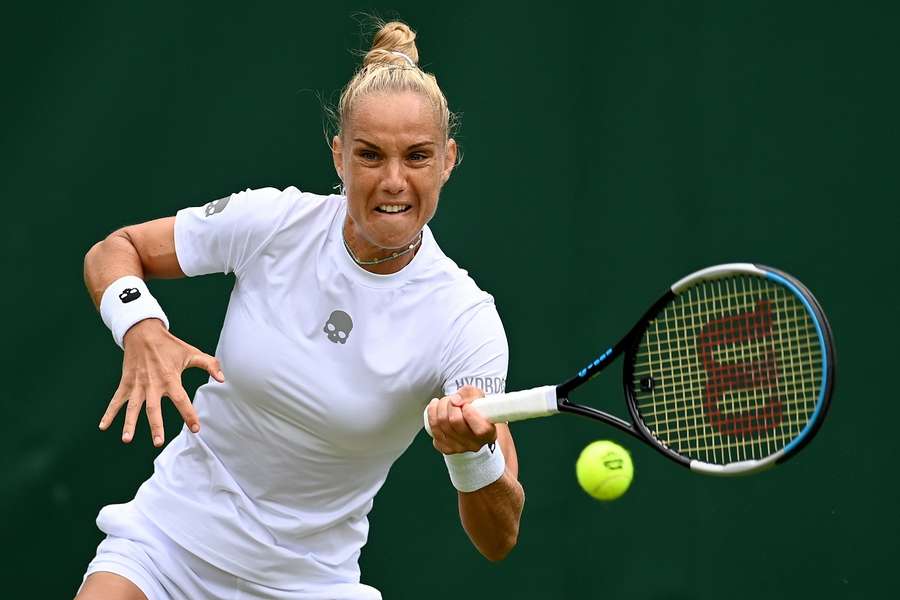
left=425, top=263, right=834, bottom=475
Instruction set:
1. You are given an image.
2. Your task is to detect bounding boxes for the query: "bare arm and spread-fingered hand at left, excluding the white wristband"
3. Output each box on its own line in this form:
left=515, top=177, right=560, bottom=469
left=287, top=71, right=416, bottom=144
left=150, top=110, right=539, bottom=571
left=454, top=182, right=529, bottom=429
left=84, top=217, right=224, bottom=447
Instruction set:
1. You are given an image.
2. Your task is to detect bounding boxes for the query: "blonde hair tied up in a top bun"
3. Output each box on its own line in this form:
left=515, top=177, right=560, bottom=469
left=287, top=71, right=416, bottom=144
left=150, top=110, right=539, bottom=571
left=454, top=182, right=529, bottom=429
left=336, top=20, right=456, bottom=140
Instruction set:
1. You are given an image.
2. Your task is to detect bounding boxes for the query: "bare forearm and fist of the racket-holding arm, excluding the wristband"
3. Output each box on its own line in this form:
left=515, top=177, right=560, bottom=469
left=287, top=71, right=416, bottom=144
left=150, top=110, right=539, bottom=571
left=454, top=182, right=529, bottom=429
left=428, top=386, right=525, bottom=561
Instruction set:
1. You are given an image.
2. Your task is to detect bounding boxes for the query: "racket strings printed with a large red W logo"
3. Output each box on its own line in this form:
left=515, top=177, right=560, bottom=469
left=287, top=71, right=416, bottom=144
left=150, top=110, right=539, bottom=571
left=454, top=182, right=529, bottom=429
left=632, top=275, right=823, bottom=464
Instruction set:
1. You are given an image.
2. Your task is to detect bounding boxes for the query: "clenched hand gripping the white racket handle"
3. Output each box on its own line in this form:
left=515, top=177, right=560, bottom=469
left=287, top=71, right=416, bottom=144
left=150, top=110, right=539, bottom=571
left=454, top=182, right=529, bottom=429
left=428, top=385, right=497, bottom=454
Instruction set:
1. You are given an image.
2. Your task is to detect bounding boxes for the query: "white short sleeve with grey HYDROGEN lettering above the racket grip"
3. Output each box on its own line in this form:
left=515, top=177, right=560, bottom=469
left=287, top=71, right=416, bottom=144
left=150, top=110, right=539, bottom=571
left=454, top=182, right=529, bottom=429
left=442, top=296, right=509, bottom=395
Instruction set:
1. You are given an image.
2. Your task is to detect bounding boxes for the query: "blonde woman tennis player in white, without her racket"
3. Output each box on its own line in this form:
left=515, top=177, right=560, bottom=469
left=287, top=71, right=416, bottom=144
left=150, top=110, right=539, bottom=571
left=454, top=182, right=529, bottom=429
left=78, top=22, right=524, bottom=600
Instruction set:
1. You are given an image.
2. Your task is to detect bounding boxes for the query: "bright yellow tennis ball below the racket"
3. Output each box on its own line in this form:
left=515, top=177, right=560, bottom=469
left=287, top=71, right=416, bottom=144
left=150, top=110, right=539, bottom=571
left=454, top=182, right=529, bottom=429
left=575, top=440, right=634, bottom=500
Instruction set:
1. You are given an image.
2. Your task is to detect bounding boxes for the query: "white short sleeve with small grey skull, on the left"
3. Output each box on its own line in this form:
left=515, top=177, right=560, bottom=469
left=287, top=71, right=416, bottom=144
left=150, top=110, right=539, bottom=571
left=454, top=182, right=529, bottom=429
left=175, top=188, right=291, bottom=277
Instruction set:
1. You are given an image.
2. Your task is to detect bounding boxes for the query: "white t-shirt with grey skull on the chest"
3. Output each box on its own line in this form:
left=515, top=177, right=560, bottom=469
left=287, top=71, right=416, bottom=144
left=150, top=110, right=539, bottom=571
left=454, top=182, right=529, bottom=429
left=98, top=187, right=508, bottom=597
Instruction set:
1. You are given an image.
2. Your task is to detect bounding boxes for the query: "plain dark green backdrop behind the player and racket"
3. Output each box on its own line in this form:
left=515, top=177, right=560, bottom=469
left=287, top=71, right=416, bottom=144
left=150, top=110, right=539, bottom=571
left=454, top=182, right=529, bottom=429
left=0, top=1, right=900, bottom=600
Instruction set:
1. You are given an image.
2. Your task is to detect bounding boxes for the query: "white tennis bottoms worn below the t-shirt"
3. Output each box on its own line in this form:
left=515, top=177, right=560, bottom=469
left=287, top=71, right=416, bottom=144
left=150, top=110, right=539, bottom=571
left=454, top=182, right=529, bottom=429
left=82, top=504, right=381, bottom=600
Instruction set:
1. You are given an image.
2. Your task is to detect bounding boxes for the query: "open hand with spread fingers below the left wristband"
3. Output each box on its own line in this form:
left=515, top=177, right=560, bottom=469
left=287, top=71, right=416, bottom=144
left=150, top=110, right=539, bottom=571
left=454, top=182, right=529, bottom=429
left=100, top=319, right=225, bottom=448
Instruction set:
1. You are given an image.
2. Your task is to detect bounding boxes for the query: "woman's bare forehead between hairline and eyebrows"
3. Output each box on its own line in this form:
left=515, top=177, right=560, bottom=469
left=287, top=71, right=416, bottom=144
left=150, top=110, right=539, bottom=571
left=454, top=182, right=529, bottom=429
left=345, top=92, right=442, bottom=143
